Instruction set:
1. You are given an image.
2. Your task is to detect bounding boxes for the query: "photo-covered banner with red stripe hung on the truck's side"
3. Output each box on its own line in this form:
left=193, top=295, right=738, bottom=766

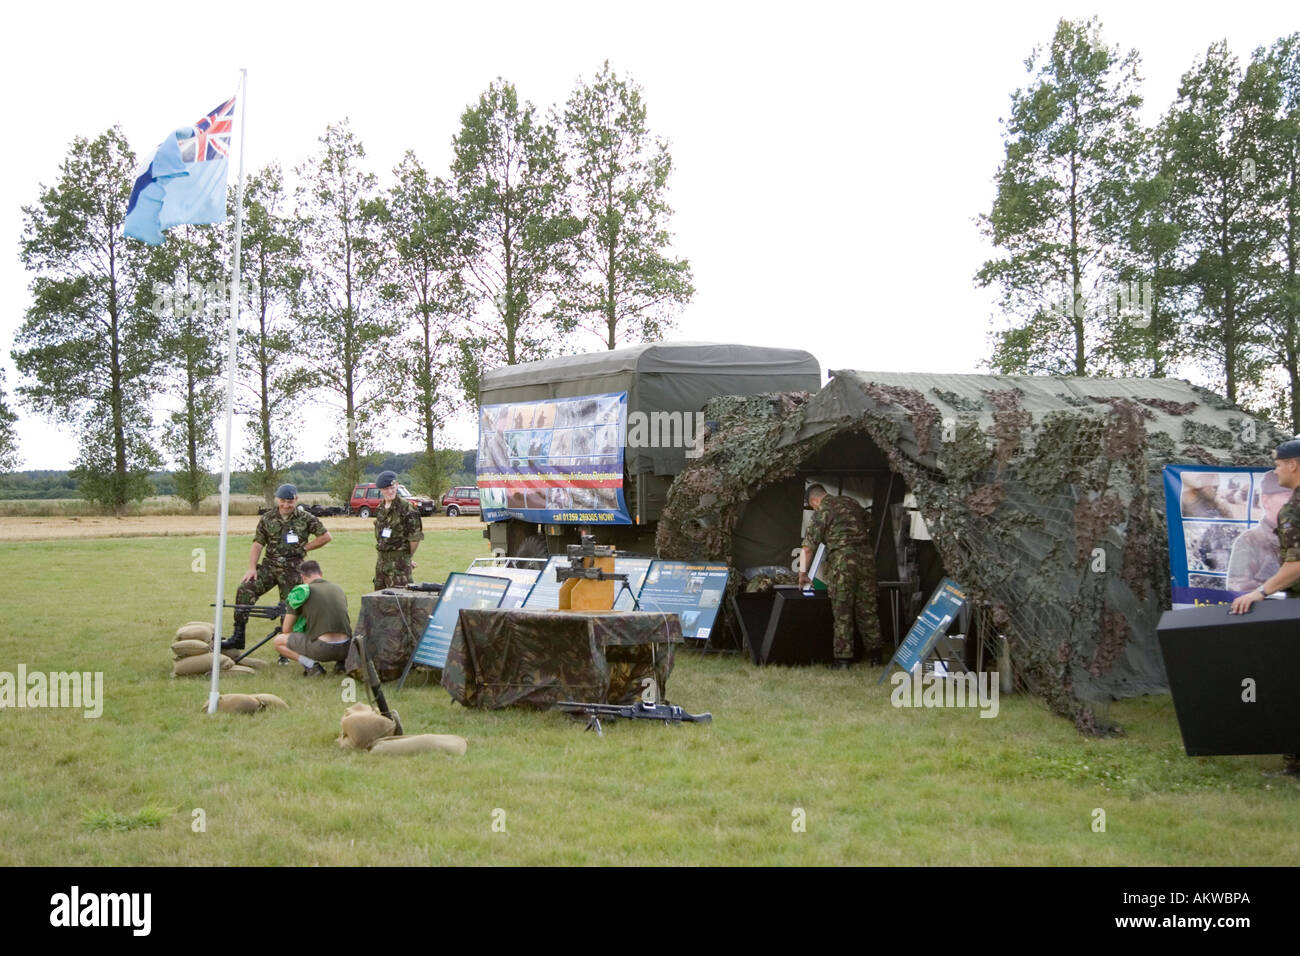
left=477, top=392, right=632, bottom=524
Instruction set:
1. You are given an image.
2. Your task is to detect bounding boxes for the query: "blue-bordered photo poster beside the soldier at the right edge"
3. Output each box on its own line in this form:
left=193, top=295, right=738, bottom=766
left=1165, top=464, right=1291, bottom=609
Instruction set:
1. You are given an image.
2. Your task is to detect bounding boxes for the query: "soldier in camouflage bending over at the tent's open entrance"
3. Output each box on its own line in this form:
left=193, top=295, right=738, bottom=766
left=800, top=485, right=884, bottom=667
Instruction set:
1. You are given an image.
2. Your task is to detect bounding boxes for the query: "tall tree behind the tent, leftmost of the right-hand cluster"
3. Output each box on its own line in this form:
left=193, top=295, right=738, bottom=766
left=975, top=18, right=1141, bottom=375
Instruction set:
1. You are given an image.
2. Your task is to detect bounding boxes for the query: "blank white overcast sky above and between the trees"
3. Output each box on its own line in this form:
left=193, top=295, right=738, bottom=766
left=0, top=0, right=1300, bottom=468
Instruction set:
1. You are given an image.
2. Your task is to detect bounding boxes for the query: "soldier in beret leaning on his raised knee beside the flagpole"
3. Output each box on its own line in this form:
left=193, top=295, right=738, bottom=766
left=221, top=485, right=330, bottom=650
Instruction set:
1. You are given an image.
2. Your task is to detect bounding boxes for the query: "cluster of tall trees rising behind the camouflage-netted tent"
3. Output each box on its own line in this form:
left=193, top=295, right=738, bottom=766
left=975, top=18, right=1300, bottom=432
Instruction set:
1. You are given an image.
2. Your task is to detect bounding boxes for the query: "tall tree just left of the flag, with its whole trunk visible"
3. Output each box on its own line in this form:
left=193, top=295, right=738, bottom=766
left=12, top=127, right=160, bottom=515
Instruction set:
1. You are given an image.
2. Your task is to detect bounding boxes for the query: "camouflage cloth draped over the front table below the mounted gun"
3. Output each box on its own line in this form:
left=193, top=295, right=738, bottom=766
left=442, top=609, right=683, bottom=710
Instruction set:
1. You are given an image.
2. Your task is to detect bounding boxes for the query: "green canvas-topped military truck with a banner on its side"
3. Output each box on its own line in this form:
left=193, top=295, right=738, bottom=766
left=477, top=342, right=822, bottom=557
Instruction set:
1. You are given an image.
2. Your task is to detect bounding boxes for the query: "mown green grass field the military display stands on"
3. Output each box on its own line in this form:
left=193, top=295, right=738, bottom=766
left=0, top=525, right=1300, bottom=865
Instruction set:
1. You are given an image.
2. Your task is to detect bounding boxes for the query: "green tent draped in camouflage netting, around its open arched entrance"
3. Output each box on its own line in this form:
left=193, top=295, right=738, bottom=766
left=657, top=371, right=1288, bottom=734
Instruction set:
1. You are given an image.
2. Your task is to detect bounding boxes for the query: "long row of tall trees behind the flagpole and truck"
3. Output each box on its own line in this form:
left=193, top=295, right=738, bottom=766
left=0, top=62, right=694, bottom=514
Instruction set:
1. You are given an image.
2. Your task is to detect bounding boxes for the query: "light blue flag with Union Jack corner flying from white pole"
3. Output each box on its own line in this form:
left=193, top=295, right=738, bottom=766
left=122, top=96, right=235, bottom=246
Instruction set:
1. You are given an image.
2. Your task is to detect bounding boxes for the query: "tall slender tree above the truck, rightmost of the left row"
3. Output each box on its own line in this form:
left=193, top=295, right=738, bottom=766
left=563, top=61, right=696, bottom=349
